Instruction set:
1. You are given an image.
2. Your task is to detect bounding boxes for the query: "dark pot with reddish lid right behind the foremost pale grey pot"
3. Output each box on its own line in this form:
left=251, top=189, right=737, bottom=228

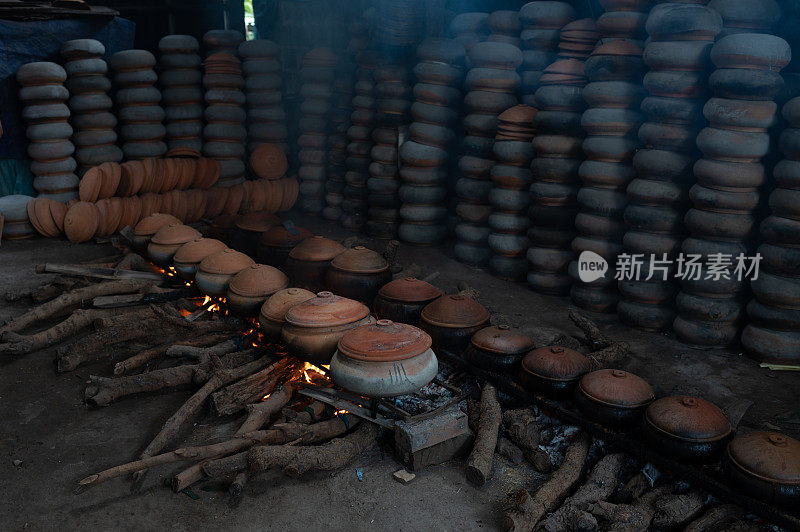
left=373, top=277, right=442, bottom=326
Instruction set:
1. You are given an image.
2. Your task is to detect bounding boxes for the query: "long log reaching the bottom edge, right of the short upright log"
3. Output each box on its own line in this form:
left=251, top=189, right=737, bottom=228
left=503, top=434, right=589, bottom=532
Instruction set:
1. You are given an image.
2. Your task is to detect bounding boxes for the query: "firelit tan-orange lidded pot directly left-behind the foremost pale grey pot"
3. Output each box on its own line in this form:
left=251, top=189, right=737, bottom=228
left=281, top=292, right=375, bottom=365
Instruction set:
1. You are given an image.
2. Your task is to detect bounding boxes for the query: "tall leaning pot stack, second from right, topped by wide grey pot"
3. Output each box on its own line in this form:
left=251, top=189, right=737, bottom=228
left=673, top=33, right=791, bottom=347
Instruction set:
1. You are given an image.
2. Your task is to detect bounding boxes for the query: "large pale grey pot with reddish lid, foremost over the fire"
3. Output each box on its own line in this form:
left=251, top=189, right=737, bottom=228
left=331, top=320, right=439, bottom=397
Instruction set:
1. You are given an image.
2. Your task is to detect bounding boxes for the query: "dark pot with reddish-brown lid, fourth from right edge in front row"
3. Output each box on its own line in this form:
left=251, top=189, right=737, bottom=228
left=519, top=346, right=592, bottom=397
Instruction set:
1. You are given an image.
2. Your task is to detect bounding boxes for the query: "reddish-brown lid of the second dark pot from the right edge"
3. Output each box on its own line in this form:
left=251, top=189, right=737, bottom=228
left=645, top=395, right=731, bottom=443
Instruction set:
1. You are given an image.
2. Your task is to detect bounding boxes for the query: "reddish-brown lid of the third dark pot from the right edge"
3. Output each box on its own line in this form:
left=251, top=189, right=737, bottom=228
left=578, top=369, right=656, bottom=408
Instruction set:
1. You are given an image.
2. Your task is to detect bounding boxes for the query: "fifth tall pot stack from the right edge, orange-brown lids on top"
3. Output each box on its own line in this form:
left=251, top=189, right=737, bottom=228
left=528, top=59, right=586, bottom=295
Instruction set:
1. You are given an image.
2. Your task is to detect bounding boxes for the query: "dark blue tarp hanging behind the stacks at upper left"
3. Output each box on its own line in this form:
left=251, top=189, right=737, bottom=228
left=0, top=17, right=136, bottom=195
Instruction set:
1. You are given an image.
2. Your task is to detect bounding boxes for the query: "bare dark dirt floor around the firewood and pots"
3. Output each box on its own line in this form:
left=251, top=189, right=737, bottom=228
left=0, top=217, right=800, bottom=531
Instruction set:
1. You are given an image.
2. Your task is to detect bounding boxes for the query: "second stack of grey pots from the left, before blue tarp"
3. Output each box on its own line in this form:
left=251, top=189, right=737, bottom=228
left=61, top=39, right=122, bottom=175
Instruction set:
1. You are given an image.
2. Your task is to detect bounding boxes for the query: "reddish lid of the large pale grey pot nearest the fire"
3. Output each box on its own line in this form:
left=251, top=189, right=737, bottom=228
left=338, top=320, right=433, bottom=362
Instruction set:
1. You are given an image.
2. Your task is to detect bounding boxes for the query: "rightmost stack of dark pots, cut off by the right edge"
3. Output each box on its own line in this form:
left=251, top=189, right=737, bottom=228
left=742, top=98, right=800, bottom=365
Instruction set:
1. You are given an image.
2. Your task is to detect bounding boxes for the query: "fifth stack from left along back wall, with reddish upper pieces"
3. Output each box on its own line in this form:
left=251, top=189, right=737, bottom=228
left=203, top=52, right=247, bottom=187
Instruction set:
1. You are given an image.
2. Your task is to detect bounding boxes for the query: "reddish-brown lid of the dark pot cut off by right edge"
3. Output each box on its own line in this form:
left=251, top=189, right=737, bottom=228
left=726, top=431, right=800, bottom=486
